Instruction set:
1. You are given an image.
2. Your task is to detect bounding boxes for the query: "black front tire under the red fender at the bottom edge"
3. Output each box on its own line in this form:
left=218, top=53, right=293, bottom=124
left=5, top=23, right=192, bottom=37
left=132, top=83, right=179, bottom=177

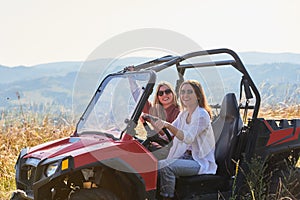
left=69, top=188, right=119, bottom=200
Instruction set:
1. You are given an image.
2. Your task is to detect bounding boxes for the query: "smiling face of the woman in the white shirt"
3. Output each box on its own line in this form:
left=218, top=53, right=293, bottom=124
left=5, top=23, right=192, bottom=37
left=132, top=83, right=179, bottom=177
left=179, top=83, right=198, bottom=108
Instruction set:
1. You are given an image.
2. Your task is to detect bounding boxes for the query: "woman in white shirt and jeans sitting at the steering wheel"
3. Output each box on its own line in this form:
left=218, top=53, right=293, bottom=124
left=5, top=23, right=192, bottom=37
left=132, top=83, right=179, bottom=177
left=151, top=80, right=217, bottom=199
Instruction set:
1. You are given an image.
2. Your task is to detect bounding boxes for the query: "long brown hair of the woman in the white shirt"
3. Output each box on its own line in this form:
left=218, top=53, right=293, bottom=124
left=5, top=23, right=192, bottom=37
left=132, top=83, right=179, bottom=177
left=179, top=80, right=212, bottom=117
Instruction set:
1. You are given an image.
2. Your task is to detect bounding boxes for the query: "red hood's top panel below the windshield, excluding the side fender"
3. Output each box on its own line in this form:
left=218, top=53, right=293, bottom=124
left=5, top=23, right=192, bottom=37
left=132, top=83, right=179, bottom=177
left=25, top=135, right=114, bottom=160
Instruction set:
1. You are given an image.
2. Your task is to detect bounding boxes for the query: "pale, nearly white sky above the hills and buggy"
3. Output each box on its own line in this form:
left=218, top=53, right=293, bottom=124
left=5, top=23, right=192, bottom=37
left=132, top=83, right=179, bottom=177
left=0, top=0, right=300, bottom=66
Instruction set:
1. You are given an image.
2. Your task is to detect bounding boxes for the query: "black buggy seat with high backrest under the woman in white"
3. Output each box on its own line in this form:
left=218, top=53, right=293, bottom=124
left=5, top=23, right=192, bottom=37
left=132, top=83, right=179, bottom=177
left=176, top=93, right=243, bottom=199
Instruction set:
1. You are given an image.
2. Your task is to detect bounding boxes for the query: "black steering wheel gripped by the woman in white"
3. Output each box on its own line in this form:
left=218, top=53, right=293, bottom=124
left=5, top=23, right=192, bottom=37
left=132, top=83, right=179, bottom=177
left=142, top=115, right=172, bottom=147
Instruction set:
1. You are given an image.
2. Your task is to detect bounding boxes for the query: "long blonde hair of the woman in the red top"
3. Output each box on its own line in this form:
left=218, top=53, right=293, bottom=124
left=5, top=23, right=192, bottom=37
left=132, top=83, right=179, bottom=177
left=150, top=81, right=179, bottom=120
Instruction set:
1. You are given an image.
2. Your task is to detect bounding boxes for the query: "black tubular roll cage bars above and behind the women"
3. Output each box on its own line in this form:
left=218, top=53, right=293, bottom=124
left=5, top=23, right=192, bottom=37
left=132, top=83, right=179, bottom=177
left=125, top=48, right=261, bottom=123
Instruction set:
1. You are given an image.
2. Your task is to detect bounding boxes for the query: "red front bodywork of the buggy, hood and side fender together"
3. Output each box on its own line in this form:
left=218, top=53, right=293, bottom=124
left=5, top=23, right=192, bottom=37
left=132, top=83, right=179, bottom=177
left=24, top=134, right=157, bottom=190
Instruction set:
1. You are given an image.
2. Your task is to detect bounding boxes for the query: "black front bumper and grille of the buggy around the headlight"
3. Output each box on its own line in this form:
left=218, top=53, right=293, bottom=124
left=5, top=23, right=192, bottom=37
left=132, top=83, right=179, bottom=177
left=11, top=149, right=74, bottom=200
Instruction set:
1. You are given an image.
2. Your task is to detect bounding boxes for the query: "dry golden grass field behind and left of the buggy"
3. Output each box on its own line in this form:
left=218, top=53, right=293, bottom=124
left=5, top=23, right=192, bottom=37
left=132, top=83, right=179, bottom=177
left=0, top=105, right=300, bottom=199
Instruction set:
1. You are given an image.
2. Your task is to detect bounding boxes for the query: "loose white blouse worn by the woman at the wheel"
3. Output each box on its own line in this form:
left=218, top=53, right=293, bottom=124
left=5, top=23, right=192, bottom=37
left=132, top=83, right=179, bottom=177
left=167, top=107, right=217, bottom=174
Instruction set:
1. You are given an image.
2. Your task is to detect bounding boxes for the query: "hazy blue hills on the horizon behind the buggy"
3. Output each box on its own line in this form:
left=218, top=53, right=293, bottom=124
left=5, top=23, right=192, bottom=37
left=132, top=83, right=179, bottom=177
left=0, top=52, right=300, bottom=114
